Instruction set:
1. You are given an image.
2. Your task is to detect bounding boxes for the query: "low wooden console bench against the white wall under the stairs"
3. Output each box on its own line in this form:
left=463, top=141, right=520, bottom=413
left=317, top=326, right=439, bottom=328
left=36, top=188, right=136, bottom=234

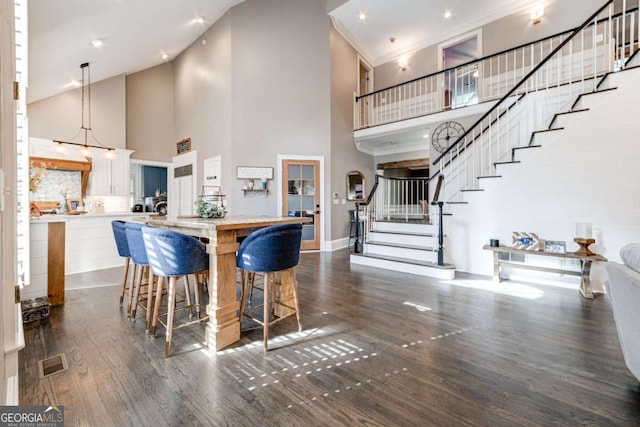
left=482, top=245, right=607, bottom=299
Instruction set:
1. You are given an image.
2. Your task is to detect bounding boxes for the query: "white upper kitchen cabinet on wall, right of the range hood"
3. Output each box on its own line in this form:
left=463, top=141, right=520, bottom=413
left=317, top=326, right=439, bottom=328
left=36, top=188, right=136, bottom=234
left=89, top=149, right=133, bottom=196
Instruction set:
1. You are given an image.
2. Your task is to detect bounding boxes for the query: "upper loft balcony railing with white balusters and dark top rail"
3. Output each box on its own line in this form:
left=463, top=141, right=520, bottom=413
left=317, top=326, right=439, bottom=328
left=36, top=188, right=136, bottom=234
left=354, top=0, right=638, bottom=130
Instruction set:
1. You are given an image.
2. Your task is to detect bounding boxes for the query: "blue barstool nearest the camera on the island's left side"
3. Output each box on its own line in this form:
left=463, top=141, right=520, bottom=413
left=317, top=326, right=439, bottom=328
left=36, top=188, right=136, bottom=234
left=142, top=227, right=209, bottom=357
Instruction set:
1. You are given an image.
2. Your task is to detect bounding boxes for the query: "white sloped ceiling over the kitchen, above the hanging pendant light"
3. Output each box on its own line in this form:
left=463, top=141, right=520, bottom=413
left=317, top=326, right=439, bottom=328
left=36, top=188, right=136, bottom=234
left=28, top=0, right=243, bottom=102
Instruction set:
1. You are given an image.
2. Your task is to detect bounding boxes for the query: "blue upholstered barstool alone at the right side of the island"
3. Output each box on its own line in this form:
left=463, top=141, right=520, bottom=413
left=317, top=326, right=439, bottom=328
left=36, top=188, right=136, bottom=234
left=236, top=224, right=302, bottom=351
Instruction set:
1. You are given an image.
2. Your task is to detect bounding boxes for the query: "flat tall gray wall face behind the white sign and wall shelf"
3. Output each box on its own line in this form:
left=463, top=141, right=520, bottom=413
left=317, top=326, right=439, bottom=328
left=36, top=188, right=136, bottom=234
left=229, top=0, right=331, bottom=221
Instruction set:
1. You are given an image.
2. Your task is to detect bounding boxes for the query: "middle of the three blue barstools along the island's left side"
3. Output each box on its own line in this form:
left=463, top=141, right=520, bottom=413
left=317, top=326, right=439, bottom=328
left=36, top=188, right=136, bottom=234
left=125, top=222, right=171, bottom=332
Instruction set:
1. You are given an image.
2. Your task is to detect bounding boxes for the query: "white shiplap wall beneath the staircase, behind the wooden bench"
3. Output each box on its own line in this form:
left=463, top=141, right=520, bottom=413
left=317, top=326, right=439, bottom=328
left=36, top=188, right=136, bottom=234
left=447, top=70, right=640, bottom=290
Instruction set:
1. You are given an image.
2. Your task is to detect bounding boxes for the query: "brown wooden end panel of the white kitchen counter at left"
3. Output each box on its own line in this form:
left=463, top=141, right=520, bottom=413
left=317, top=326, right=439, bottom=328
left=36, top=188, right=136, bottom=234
left=47, top=222, right=65, bottom=305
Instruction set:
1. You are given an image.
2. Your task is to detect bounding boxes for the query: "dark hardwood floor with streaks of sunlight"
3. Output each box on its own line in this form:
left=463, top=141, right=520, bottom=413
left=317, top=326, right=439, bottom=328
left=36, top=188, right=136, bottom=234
left=20, top=250, right=640, bottom=427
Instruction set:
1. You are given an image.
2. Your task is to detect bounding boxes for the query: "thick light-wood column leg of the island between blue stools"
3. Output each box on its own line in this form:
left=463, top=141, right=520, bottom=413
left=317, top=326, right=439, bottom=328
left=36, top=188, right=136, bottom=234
left=206, top=230, right=240, bottom=351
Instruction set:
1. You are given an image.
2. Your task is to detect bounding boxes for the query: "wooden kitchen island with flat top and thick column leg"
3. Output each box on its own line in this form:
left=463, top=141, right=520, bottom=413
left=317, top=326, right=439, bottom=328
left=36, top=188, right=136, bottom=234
left=139, top=216, right=310, bottom=350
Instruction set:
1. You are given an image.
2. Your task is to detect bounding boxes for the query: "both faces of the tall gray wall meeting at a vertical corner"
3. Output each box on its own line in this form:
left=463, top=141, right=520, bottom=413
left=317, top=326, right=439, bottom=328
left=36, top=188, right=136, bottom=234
left=174, top=0, right=331, bottom=240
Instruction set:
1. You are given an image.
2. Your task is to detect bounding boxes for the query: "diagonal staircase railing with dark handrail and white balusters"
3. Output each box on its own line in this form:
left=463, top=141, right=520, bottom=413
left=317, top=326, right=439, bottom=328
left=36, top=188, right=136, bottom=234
left=432, top=0, right=640, bottom=203
